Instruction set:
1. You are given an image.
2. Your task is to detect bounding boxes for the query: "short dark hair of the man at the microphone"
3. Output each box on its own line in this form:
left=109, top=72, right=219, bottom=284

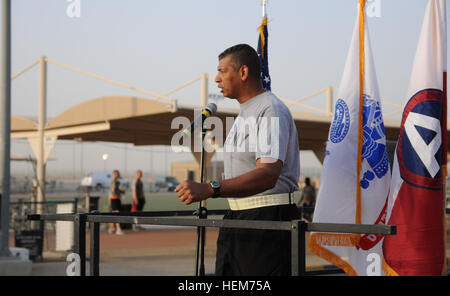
left=219, top=44, right=261, bottom=79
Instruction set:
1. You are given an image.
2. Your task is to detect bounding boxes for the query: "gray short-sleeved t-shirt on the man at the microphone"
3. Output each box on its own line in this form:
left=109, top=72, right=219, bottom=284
left=224, top=92, right=300, bottom=195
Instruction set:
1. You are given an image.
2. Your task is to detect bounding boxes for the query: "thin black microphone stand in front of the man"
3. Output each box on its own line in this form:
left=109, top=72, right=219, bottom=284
left=195, top=120, right=208, bottom=276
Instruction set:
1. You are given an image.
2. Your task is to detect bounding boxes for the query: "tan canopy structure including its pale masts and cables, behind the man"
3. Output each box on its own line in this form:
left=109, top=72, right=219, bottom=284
left=7, top=56, right=450, bottom=213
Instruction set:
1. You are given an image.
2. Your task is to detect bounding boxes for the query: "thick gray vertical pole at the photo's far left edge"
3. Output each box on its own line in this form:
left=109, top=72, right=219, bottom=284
left=0, top=0, right=11, bottom=257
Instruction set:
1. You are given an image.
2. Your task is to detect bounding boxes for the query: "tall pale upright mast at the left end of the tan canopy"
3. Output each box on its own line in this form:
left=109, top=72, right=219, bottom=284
left=36, top=56, right=47, bottom=214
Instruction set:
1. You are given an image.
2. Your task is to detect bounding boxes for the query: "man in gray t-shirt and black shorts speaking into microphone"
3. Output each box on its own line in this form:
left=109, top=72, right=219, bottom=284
left=175, top=44, right=300, bottom=276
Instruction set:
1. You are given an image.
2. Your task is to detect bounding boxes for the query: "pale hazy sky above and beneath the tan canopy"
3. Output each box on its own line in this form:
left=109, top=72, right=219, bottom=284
left=7, top=0, right=450, bottom=179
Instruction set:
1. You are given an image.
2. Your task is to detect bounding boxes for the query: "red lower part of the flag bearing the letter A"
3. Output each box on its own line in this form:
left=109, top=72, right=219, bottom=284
left=383, top=182, right=445, bottom=276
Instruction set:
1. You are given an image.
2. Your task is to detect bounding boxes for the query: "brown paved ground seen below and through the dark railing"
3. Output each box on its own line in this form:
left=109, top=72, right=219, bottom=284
left=26, top=228, right=329, bottom=276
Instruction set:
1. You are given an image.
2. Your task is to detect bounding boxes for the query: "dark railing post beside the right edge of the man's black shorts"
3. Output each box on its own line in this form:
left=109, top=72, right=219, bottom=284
left=291, top=220, right=306, bottom=276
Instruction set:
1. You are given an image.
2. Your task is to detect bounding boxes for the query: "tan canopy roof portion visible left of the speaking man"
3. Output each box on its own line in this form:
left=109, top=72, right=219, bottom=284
left=11, top=96, right=234, bottom=145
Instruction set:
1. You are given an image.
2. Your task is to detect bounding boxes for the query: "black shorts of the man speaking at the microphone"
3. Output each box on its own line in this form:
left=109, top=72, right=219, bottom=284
left=216, top=204, right=300, bottom=276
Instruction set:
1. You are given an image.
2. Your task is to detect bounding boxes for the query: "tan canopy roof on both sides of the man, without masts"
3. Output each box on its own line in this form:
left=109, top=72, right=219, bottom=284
left=11, top=96, right=408, bottom=159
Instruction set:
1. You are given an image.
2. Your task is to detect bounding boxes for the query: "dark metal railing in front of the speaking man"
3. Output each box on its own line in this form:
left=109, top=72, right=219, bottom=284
left=28, top=210, right=397, bottom=276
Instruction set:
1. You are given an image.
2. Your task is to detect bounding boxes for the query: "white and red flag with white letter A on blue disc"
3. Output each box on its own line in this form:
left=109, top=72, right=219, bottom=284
left=383, top=0, right=447, bottom=276
